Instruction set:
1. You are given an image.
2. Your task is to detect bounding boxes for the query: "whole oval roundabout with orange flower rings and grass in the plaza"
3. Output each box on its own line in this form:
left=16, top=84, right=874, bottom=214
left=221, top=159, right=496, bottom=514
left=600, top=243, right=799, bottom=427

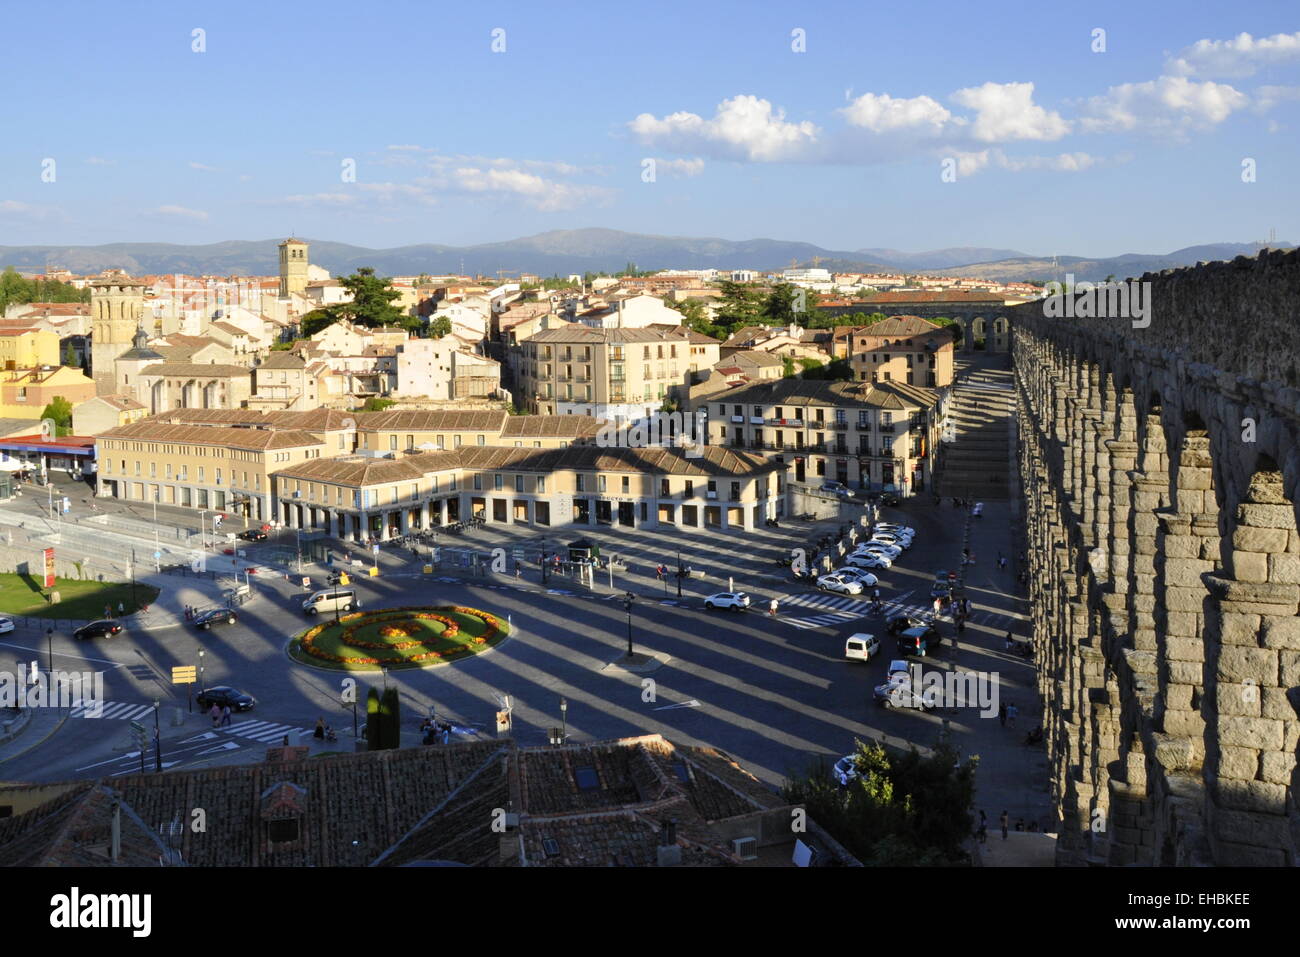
left=289, top=605, right=510, bottom=671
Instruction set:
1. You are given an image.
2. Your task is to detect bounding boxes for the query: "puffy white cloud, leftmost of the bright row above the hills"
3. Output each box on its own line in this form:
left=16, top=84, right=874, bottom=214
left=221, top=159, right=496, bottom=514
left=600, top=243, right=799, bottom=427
left=628, top=95, right=819, bottom=163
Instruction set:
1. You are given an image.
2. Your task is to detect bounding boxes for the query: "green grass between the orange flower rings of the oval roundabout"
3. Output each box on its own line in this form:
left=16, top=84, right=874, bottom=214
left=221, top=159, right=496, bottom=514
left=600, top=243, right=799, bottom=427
left=289, top=607, right=510, bottom=671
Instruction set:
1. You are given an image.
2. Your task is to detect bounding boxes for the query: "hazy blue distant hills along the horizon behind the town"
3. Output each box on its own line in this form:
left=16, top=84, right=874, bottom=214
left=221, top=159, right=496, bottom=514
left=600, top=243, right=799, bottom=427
left=0, top=229, right=1292, bottom=281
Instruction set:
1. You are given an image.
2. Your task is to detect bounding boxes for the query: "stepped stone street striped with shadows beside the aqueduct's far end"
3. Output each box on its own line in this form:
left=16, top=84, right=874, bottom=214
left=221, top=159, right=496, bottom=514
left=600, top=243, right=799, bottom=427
left=936, top=355, right=1015, bottom=501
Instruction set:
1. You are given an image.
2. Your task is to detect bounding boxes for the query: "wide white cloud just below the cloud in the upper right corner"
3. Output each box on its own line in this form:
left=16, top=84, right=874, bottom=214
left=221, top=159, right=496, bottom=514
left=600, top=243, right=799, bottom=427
left=1080, top=77, right=1249, bottom=134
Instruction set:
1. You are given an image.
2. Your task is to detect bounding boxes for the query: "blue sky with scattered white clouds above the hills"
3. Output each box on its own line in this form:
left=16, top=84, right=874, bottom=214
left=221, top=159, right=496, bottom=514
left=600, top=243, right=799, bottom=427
left=0, top=0, right=1300, bottom=256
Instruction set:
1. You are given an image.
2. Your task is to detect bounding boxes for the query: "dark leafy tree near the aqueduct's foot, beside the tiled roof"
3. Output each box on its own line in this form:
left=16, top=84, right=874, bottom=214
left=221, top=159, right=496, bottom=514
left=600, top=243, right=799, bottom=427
left=781, top=741, right=979, bottom=867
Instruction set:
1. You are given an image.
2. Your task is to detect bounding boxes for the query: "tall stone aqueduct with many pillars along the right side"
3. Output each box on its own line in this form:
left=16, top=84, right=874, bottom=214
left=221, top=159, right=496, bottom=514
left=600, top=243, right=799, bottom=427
left=1011, top=251, right=1300, bottom=865
